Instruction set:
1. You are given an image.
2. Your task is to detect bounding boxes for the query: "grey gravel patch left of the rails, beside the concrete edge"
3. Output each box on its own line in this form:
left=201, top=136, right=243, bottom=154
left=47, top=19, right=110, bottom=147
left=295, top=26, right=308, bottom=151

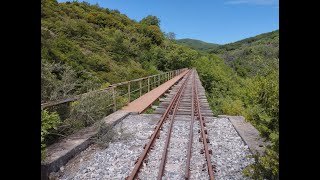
left=51, top=115, right=160, bottom=180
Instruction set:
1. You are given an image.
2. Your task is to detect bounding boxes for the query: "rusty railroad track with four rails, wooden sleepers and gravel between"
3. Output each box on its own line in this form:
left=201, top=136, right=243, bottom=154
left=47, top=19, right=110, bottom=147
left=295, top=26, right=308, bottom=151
left=127, top=70, right=215, bottom=180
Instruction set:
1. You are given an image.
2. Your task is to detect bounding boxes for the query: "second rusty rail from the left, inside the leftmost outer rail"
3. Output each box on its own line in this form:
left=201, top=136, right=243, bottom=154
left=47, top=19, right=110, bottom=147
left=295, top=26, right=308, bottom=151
left=157, top=71, right=193, bottom=180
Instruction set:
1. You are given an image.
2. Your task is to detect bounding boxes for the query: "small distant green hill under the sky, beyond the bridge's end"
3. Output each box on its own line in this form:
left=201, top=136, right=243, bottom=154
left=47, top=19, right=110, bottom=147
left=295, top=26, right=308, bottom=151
left=176, top=38, right=219, bottom=52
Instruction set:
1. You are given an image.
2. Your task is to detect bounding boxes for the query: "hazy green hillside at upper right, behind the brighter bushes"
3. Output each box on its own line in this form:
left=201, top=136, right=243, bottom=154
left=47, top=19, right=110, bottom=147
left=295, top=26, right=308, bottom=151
left=210, top=30, right=279, bottom=77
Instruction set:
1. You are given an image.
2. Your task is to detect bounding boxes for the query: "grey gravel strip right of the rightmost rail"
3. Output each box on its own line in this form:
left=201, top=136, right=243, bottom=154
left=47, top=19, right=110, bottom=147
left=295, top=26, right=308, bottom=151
left=206, top=118, right=254, bottom=180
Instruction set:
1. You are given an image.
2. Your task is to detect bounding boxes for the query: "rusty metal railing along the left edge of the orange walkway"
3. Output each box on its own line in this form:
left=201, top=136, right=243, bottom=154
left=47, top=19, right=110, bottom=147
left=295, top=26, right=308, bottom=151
left=41, top=68, right=188, bottom=112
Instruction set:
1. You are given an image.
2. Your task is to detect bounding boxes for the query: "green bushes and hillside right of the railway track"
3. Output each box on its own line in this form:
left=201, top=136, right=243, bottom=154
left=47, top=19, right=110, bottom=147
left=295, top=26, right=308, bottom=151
left=194, top=30, right=279, bottom=179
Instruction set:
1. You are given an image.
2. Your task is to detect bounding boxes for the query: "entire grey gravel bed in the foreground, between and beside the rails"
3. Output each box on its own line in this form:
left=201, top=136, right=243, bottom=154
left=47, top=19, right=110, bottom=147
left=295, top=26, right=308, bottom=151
left=51, top=115, right=254, bottom=180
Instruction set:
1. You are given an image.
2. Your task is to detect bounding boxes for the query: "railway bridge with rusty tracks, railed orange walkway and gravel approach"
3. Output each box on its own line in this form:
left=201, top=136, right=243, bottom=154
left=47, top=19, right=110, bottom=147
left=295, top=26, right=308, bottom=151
left=41, top=69, right=266, bottom=180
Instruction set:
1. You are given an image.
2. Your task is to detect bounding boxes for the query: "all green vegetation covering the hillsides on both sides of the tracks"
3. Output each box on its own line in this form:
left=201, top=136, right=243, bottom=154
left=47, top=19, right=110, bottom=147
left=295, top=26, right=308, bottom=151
left=41, top=0, right=279, bottom=179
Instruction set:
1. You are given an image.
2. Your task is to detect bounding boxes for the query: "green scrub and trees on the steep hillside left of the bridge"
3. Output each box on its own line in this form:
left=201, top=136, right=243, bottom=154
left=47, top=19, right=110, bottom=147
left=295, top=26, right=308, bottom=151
left=41, top=0, right=199, bottom=160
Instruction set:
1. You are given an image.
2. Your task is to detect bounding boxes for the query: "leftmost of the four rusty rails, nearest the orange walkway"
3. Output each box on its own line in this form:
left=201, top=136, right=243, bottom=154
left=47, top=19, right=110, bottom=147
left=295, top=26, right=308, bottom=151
left=128, top=70, right=191, bottom=180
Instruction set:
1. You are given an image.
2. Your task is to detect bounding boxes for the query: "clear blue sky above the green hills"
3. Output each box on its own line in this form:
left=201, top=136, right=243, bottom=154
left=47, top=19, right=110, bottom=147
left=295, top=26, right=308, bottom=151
left=58, top=0, right=279, bottom=44
